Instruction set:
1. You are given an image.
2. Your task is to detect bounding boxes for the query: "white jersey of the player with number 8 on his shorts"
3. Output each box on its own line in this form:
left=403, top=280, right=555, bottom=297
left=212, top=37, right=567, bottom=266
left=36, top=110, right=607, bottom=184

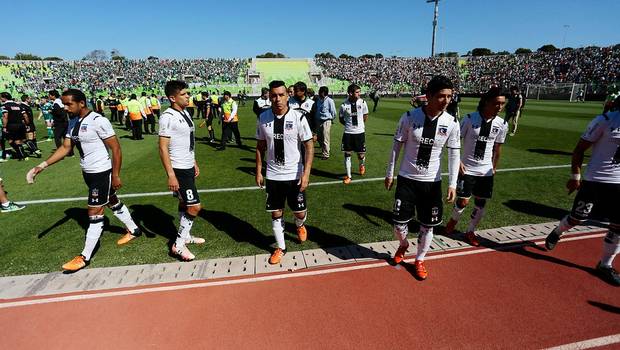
left=159, top=107, right=195, bottom=169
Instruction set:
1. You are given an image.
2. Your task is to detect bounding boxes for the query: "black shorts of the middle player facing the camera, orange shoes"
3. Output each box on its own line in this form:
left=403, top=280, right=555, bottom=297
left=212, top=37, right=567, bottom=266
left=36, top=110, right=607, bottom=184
left=265, top=180, right=306, bottom=213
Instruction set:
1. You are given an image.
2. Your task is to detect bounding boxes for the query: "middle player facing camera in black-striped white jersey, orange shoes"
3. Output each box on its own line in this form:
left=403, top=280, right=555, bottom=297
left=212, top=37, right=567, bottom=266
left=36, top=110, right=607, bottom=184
left=256, top=80, right=314, bottom=264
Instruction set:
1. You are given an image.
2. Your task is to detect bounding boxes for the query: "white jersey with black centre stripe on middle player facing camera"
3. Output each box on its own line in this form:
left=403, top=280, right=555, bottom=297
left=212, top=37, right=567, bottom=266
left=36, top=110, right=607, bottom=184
left=256, top=108, right=312, bottom=181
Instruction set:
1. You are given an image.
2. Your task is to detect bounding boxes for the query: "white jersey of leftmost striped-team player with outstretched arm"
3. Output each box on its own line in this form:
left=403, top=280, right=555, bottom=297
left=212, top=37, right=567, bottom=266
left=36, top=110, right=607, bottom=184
left=66, top=112, right=115, bottom=174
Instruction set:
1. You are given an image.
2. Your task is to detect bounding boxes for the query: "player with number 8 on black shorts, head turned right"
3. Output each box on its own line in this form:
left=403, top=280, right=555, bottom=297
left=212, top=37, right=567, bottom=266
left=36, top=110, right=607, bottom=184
left=159, top=80, right=205, bottom=261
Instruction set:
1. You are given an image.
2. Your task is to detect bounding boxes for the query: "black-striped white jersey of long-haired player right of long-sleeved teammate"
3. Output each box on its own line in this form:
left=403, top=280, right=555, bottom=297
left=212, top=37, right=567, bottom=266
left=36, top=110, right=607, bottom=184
left=461, top=112, right=508, bottom=176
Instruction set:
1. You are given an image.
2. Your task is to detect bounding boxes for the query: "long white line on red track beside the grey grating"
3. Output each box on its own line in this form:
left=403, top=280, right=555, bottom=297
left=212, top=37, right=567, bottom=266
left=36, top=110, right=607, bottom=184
left=0, top=233, right=604, bottom=309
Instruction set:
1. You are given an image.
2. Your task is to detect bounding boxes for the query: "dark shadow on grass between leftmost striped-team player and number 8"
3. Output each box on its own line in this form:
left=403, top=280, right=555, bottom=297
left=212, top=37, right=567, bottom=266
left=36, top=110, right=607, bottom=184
left=130, top=204, right=177, bottom=242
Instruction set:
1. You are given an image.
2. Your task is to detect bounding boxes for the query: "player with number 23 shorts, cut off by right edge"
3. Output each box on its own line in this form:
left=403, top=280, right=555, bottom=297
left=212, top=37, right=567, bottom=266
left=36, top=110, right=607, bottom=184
left=545, top=111, right=620, bottom=286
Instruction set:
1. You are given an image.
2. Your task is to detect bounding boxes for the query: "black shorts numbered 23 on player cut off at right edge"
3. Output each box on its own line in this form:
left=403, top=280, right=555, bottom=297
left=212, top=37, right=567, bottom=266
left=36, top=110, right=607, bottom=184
left=570, top=181, right=620, bottom=224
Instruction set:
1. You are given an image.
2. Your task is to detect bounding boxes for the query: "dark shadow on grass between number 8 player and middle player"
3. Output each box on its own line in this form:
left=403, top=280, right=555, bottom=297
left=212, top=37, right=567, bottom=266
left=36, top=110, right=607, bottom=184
left=198, top=209, right=273, bottom=251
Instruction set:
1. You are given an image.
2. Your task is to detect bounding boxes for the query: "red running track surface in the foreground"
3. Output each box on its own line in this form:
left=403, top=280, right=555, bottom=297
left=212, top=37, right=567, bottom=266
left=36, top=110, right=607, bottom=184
left=0, top=232, right=620, bottom=350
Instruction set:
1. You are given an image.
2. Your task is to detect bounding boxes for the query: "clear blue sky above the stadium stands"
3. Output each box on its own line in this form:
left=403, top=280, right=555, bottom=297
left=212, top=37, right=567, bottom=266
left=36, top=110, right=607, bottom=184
left=0, top=0, right=620, bottom=59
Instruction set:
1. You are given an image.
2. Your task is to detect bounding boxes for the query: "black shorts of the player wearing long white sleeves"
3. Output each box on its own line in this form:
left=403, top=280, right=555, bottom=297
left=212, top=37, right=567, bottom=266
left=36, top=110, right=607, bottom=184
left=392, top=176, right=443, bottom=227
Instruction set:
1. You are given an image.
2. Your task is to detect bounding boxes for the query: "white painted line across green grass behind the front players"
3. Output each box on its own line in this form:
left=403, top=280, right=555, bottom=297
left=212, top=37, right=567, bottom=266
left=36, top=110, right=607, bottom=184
left=17, top=164, right=570, bottom=205
